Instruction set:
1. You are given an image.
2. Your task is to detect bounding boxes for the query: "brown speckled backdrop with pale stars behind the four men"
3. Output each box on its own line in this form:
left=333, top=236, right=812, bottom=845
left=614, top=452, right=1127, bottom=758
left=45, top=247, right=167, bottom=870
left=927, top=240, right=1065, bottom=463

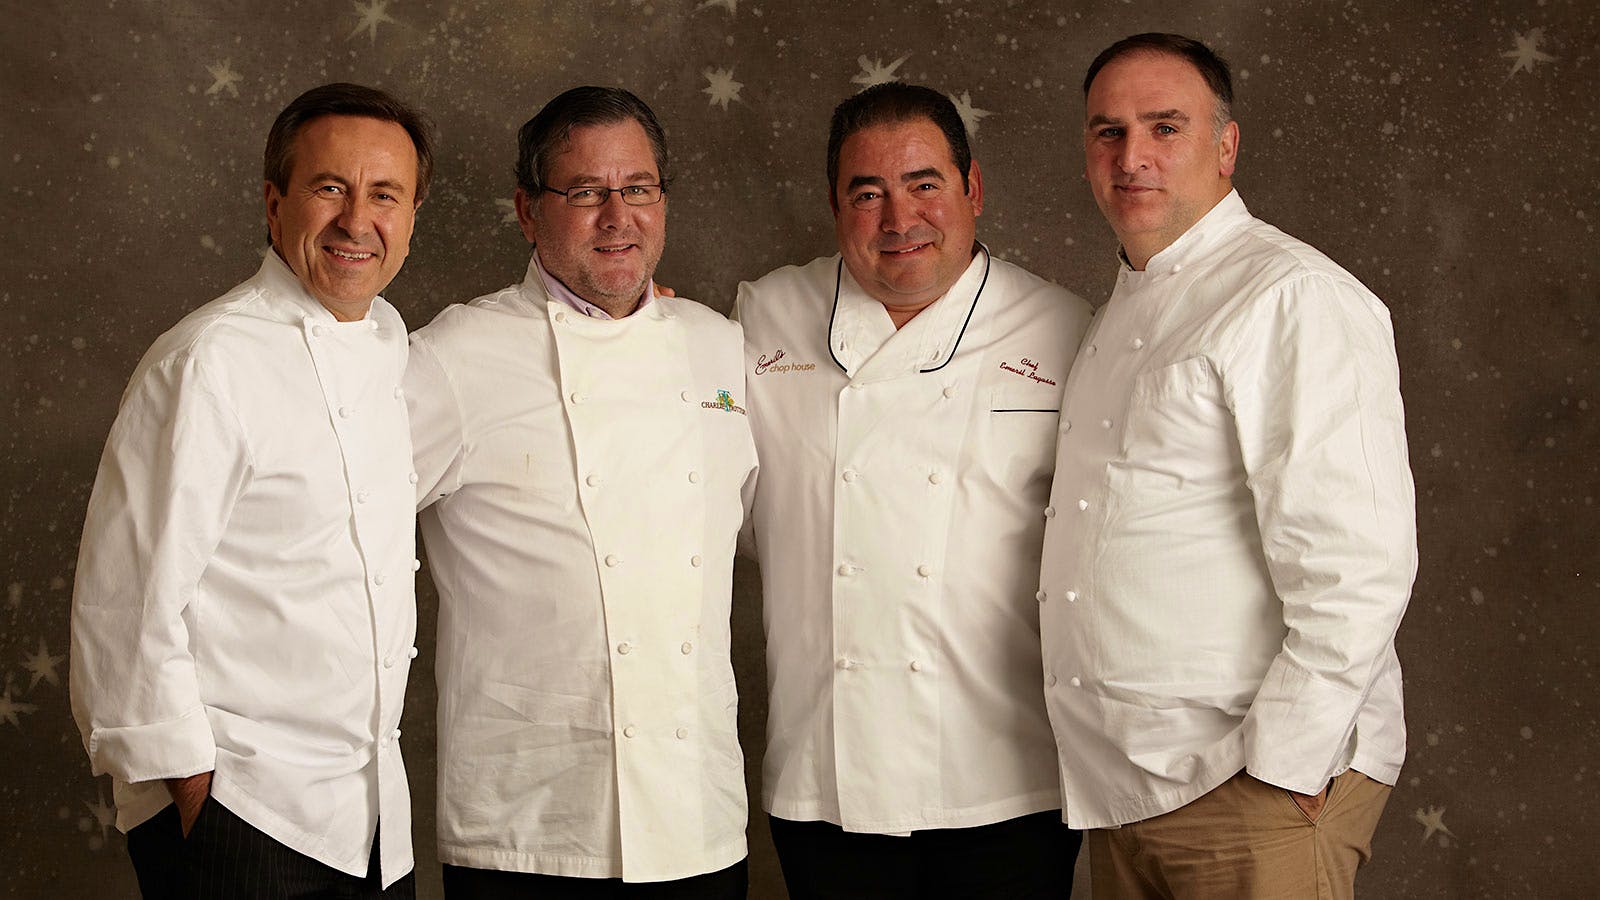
left=0, top=0, right=1600, bottom=898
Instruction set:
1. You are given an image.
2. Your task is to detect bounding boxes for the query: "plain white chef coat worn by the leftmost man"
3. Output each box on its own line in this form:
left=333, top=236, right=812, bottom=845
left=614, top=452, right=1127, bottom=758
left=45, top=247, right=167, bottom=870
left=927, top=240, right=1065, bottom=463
left=72, top=253, right=416, bottom=886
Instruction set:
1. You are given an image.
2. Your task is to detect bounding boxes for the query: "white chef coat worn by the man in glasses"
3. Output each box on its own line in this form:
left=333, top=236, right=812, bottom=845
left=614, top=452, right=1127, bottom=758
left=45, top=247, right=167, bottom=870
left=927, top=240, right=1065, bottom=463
left=406, top=256, right=755, bottom=881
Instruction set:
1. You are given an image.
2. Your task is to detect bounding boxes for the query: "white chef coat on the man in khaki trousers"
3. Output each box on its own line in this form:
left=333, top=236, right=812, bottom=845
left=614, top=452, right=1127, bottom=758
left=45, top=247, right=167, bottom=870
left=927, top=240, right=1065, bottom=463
left=1040, top=194, right=1416, bottom=828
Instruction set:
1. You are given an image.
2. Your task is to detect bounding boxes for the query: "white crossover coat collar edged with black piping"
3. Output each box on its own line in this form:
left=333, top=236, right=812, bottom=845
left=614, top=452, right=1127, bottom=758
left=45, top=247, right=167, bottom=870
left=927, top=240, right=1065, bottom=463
left=827, top=242, right=989, bottom=381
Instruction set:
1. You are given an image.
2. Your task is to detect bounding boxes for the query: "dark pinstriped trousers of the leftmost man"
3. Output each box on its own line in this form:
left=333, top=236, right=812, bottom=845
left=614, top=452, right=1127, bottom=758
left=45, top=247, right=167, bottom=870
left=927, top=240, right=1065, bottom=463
left=128, top=798, right=416, bottom=900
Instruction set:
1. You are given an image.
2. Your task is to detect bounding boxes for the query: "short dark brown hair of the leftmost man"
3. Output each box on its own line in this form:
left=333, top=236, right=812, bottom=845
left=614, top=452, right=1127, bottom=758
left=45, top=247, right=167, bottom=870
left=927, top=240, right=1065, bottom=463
left=261, top=82, right=434, bottom=203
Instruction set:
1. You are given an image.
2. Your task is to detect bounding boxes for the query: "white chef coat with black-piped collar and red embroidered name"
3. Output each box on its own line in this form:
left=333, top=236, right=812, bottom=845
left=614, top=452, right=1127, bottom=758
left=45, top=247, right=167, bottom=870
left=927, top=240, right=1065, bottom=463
left=736, top=251, right=1090, bottom=834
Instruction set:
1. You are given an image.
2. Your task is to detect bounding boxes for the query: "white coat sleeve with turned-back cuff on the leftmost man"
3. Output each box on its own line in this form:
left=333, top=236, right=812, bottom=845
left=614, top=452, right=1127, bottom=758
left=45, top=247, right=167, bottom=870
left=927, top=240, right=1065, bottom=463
left=70, top=356, right=253, bottom=783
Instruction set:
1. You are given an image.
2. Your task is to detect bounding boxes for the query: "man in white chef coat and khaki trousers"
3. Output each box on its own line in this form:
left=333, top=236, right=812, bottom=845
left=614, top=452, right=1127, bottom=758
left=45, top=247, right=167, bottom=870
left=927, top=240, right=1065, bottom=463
left=1040, top=34, right=1416, bottom=900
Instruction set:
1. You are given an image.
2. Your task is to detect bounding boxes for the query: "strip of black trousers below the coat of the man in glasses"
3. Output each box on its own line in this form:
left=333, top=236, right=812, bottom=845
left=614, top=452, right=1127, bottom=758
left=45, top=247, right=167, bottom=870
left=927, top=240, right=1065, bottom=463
left=445, top=860, right=750, bottom=900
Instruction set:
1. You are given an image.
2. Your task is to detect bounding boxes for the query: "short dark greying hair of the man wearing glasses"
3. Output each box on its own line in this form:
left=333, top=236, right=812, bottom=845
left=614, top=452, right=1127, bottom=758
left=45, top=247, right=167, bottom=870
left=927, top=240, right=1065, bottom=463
left=514, top=85, right=669, bottom=195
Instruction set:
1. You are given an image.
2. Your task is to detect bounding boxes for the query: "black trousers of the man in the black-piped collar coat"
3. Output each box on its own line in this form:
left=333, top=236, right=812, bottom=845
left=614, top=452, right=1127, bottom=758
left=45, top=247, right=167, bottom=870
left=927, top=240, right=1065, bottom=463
left=768, top=810, right=1083, bottom=900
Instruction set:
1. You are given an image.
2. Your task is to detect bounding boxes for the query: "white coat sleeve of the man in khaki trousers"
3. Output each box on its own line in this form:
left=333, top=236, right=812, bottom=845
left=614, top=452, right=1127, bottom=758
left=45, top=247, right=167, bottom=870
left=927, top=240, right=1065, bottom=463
left=1224, top=275, right=1416, bottom=794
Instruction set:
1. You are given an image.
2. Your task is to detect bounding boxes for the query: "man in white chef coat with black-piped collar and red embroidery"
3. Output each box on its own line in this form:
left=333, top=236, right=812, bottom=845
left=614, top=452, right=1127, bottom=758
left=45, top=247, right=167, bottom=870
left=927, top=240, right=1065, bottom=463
left=736, top=83, right=1090, bottom=900
